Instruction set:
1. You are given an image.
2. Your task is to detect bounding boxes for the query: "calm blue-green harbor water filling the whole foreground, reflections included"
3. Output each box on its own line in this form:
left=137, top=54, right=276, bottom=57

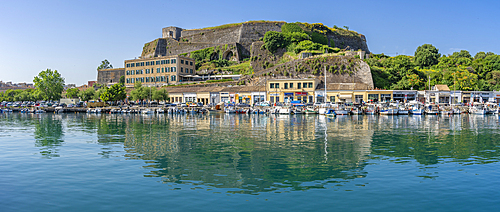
left=0, top=113, right=500, bottom=211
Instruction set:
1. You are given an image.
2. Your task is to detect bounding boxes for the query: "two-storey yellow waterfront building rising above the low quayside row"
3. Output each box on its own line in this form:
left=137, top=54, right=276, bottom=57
left=266, top=78, right=319, bottom=103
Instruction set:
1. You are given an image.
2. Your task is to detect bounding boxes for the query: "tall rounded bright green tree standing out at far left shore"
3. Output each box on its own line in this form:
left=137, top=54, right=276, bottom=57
left=33, top=69, right=64, bottom=100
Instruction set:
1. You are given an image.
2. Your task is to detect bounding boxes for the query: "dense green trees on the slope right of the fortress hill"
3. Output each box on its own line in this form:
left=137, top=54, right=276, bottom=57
left=365, top=44, right=500, bottom=91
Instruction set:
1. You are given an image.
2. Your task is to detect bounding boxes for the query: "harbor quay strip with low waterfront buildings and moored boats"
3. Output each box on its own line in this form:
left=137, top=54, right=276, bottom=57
left=2, top=79, right=500, bottom=115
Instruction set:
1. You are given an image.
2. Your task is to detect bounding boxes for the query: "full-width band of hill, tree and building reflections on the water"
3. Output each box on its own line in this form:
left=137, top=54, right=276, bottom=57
left=5, top=113, right=500, bottom=194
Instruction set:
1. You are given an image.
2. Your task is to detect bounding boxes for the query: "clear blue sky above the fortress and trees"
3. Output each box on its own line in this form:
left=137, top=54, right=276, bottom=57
left=0, top=0, right=500, bottom=85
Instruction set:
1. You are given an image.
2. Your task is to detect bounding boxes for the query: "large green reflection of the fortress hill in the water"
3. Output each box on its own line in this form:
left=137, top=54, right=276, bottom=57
left=113, top=114, right=369, bottom=193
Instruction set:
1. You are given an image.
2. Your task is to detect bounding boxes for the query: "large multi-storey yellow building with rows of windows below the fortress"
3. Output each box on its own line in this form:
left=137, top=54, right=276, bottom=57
left=125, top=55, right=196, bottom=87
